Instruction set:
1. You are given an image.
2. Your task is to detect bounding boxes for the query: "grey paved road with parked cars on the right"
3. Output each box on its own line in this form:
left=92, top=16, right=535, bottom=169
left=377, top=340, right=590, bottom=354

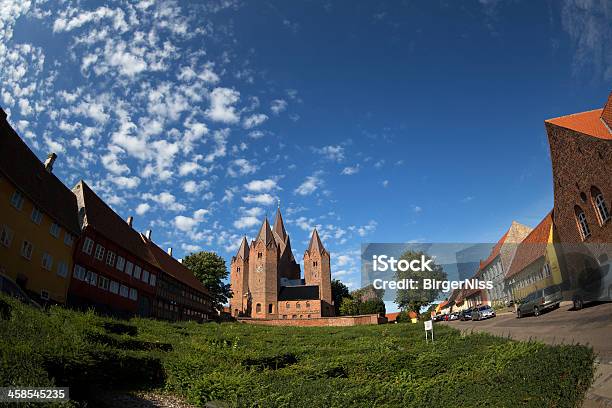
left=442, top=303, right=612, bottom=408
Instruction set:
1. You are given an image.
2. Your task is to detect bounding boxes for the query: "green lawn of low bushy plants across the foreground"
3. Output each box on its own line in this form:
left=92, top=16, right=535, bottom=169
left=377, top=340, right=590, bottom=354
left=0, top=298, right=594, bottom=407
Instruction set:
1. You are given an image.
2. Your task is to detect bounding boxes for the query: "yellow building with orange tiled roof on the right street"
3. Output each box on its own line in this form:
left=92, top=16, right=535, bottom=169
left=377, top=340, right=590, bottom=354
left=506, top=211, right=563, bottom=300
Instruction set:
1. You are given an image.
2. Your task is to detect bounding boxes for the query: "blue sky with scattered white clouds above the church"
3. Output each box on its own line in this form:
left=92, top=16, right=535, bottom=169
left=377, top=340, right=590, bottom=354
left=0, top=0, right=612, bottom=294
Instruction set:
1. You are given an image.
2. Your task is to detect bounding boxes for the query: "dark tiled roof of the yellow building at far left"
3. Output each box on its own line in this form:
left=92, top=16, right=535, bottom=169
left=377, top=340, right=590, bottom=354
left=0, top=113, right=81, bottom=235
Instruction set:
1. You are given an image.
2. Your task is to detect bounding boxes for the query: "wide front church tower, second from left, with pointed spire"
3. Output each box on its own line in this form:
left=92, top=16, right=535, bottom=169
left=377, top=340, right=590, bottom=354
left=248, top=217, right=279, bottom=318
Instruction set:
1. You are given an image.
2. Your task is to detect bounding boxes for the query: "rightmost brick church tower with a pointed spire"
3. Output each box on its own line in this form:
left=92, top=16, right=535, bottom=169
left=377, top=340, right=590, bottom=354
left=304, top=228, right=334, bottom=316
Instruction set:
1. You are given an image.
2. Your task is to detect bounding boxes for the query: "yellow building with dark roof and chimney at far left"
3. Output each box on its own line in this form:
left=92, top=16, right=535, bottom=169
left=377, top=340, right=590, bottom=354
left=0, top=109, right=80, bottom=304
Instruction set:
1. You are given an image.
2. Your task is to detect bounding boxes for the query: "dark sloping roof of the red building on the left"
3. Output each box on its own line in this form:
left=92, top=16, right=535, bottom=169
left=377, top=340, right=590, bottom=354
left=72, top=180, right=159, bottom=268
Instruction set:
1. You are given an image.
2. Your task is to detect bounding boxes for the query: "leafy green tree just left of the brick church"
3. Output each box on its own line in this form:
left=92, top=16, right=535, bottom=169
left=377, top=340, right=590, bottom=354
left=183, top=251, right=232, bottom=311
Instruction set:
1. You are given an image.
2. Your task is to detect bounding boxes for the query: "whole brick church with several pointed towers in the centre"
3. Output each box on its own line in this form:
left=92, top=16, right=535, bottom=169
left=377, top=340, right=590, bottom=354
left=230, top=208, right=334, bottom=319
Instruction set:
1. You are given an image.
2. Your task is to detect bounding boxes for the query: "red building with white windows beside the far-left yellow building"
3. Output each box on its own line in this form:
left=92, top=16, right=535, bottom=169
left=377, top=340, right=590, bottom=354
left=68, top=181, right=161, bottom=317
